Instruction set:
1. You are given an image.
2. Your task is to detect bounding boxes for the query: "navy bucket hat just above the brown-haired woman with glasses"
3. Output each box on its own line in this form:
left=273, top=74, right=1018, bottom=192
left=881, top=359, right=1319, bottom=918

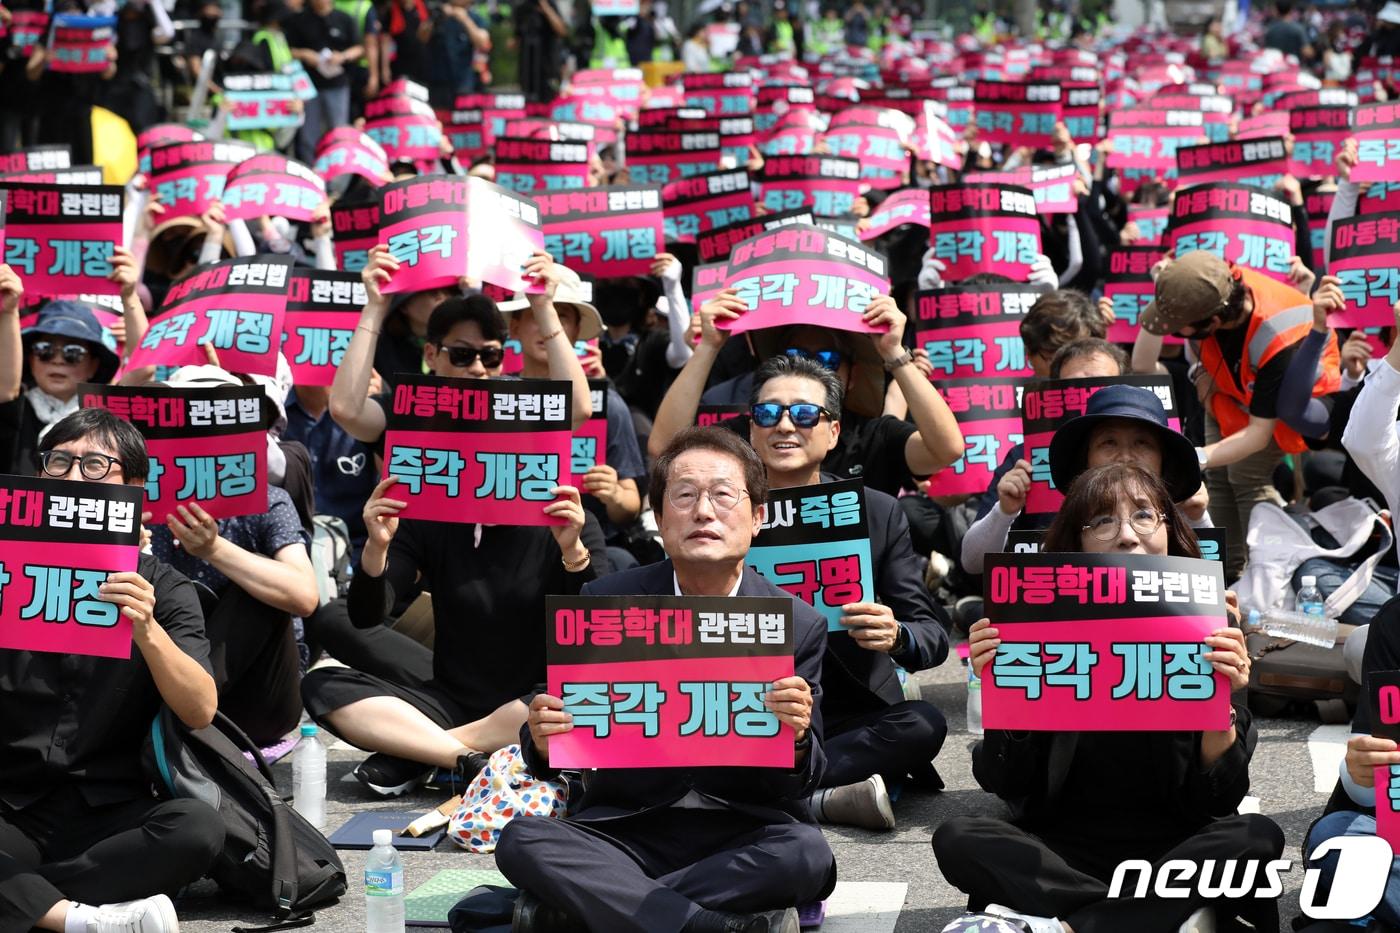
left=1050, top=385, right=1201, bottom=502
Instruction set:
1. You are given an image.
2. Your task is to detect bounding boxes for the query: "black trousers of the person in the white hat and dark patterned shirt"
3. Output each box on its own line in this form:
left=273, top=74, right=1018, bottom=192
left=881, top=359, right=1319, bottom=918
left=204, top=584, right=301, bottom=745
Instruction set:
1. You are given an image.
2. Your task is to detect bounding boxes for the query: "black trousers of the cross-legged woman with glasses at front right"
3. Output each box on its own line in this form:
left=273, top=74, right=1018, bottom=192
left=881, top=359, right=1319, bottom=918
left=934, top=812, right=1284, bottom=933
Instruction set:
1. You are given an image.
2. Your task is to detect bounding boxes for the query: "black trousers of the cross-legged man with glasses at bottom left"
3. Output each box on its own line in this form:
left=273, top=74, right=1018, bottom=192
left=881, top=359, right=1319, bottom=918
left=0, top=786, right=224, bottom=933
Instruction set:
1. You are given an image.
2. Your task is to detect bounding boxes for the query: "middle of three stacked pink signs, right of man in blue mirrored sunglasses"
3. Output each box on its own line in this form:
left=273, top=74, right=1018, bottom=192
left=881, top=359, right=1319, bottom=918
left=910, top=283, right=1044, bottom=381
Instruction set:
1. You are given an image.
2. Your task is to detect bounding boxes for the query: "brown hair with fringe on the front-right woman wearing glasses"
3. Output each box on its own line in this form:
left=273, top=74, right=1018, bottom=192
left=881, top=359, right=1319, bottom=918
left=1040, top=464, right=1201, bottom=558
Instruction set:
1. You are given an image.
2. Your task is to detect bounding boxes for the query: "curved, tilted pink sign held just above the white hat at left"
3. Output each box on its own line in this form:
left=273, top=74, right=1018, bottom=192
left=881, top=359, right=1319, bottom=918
left=129, top=255, right=293, bottom=375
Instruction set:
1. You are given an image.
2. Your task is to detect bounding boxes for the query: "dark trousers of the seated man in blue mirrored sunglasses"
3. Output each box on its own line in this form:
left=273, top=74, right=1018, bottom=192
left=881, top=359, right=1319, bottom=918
left=822, top=700, right=948, bottom=787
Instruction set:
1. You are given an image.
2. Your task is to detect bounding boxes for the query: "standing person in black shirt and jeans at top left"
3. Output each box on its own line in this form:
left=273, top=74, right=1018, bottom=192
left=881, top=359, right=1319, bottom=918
left=283, top=0, right=364, bottom=165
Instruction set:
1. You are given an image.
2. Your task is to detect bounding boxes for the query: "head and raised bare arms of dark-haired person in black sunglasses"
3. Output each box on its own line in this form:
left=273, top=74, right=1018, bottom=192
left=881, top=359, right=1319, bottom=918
left=330, top=244, right=592, bottom=444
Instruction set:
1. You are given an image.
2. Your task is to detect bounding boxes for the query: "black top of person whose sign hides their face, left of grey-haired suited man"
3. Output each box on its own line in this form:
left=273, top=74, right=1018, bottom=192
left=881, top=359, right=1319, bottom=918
left=346, top=516, right=612, bottom=716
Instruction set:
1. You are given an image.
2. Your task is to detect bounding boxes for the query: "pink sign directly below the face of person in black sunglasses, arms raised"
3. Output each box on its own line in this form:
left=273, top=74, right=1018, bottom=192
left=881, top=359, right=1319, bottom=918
left=384, top=374, right=573, bottom=525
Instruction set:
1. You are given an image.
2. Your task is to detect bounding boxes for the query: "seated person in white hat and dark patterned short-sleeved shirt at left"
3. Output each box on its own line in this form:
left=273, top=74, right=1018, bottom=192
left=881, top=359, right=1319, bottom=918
left=151, top=366, right=319, bottom=745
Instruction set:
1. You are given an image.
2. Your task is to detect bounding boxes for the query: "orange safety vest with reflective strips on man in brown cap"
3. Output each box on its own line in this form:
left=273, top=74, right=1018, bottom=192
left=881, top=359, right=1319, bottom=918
left=1201, top=266, right=1341, bottom=454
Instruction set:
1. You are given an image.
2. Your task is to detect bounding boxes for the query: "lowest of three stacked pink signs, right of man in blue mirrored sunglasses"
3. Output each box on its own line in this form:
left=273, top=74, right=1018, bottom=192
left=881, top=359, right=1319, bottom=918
left=928, top=375, right=1026, bottom=496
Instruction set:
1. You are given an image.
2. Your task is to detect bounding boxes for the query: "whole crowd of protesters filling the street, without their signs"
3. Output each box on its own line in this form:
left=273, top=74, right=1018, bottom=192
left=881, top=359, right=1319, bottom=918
left=0, top=0, right=1400, bottom=933
